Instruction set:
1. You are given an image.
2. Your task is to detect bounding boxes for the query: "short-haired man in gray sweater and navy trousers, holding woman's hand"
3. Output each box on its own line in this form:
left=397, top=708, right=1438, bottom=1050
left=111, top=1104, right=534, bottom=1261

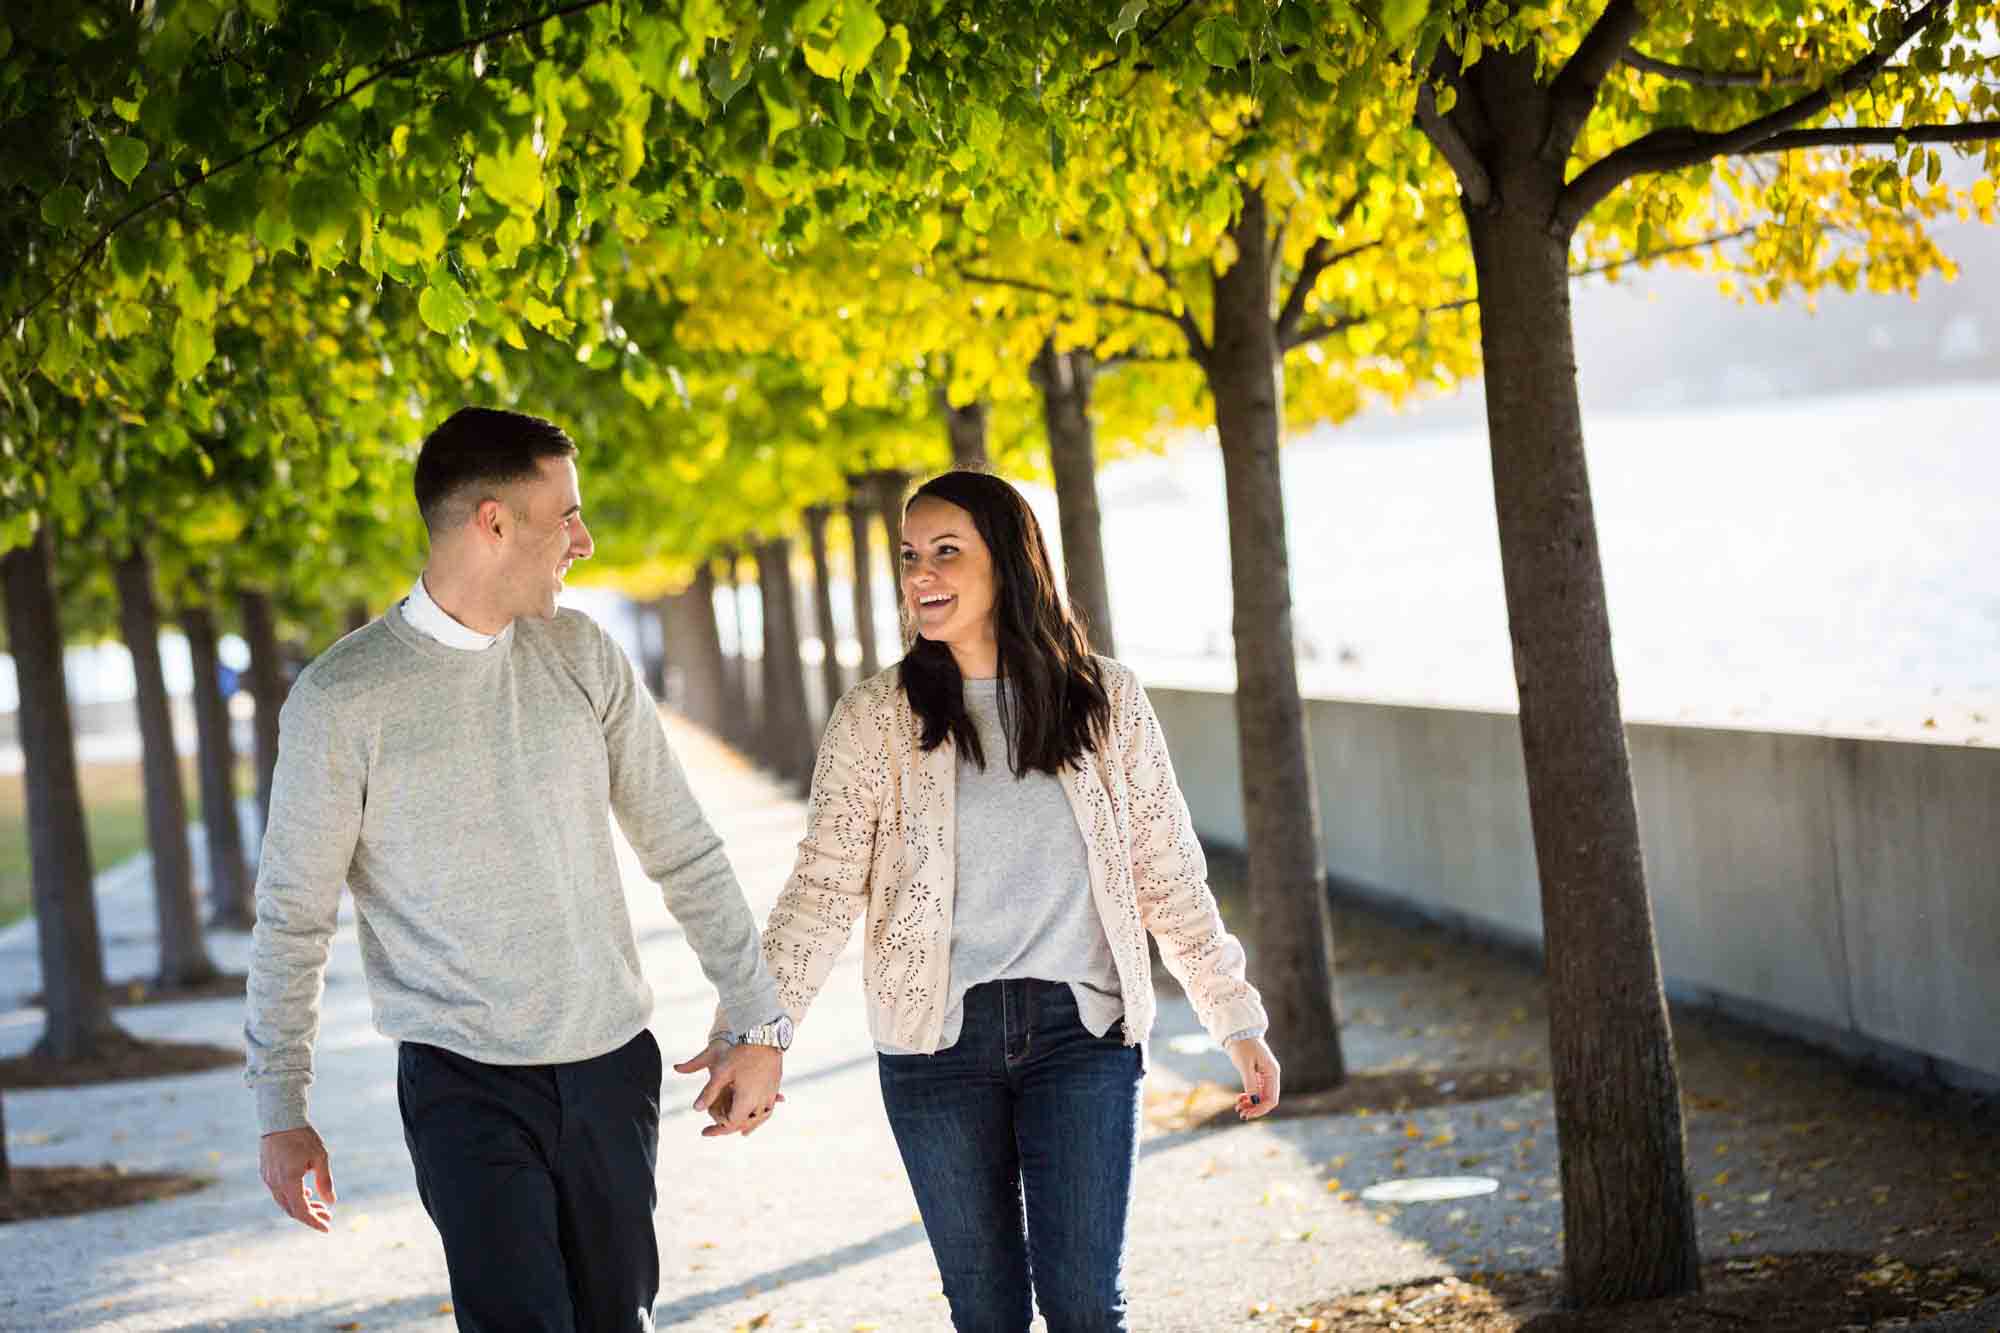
left=244, top=408, right=790, bottom=1331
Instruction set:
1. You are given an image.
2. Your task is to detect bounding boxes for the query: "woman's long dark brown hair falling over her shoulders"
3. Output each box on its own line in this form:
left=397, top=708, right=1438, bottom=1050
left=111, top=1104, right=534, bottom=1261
left=896, top=472, right=1112, bottom=777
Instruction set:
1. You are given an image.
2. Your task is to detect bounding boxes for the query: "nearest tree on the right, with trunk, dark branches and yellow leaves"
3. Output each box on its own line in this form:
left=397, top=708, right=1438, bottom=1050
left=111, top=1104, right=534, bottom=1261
left=1416, top=0, right=2000, bottom=1307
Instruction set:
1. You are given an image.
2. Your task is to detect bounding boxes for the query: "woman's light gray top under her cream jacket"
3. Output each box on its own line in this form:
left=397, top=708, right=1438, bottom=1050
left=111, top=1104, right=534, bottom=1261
left=878, top=681, right=1124, bottom=1055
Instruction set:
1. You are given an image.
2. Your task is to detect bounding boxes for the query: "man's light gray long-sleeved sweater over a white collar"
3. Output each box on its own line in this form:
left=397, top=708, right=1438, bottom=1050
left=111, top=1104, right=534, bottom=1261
left=244, top=610, right=780, bottom=1133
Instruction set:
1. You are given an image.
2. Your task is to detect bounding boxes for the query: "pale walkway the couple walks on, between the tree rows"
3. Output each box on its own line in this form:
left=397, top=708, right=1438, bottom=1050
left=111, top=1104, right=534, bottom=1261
left=0, top=723, right=2000, bottom=1333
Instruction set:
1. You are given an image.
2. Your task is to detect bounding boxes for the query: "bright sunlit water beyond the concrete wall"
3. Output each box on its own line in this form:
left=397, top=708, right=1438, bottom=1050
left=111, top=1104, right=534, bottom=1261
left=1036, top=384, right=2000, bottom=743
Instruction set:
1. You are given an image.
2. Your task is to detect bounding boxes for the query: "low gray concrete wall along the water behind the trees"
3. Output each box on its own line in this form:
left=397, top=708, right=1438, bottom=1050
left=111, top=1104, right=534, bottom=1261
left=1148, top=689, right=2000, bottom=1085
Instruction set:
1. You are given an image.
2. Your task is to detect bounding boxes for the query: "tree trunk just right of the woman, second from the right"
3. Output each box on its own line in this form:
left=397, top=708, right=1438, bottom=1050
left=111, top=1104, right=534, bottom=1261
left=1204, top=190, right=1346, bottom=1093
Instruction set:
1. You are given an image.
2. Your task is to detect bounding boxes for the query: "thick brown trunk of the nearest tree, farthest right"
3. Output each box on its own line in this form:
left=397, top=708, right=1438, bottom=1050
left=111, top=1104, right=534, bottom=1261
left=1466, top=52, right=1700, bottom=1307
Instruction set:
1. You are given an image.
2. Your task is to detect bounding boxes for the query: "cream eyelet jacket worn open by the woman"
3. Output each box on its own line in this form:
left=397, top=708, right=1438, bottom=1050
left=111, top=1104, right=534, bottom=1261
left=764, top=658, right=1266, bottom=1053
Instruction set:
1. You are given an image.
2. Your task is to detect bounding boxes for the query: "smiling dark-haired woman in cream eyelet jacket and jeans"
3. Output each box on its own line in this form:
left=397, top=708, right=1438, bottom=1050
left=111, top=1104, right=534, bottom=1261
left=680, top=472, right=1278, bottom=1333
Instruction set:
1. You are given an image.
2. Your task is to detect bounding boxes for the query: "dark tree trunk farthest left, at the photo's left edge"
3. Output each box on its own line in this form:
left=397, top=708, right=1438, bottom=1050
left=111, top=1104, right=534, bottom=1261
left=0, top=526, right=130, bottom=1061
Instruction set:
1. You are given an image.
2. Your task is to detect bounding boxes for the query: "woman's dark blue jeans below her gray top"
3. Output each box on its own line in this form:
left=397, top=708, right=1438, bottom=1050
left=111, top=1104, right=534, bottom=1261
left=880, top=981, right=1144, bottom=1333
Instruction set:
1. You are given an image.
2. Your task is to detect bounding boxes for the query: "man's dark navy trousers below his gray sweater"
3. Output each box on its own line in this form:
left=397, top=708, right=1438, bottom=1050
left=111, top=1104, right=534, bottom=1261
left=396, top=1031, right=662, bottom=1333
